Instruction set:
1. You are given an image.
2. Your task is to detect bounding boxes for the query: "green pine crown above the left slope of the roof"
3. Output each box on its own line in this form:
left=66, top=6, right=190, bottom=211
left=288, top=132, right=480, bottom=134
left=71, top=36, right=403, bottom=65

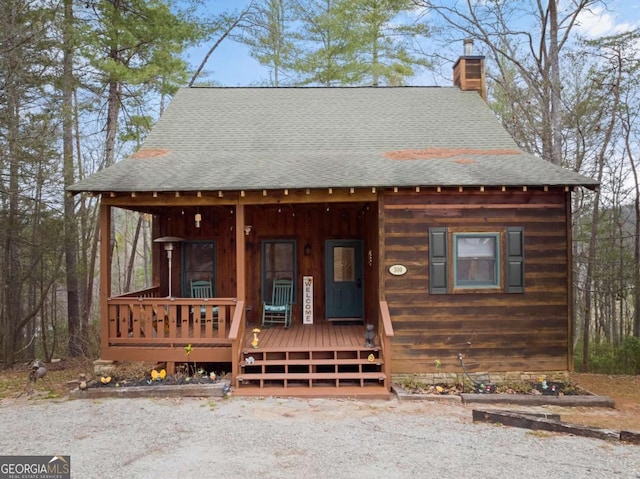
left=75, top=0, right=208, bottom=158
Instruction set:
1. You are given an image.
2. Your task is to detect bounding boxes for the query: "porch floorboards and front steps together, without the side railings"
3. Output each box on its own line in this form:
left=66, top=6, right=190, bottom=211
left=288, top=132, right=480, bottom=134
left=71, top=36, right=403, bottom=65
left=234, top=322, right=390, bottom=399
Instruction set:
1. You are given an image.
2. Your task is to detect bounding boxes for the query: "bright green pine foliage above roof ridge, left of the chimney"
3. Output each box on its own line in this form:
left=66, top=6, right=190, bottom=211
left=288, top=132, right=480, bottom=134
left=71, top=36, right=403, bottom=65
left=280, top=0, right=430, bottom=86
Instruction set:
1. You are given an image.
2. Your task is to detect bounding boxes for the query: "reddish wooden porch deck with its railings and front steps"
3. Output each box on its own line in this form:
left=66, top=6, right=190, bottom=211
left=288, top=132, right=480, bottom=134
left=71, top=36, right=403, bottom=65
left=101, top=293, right=393, bottom=398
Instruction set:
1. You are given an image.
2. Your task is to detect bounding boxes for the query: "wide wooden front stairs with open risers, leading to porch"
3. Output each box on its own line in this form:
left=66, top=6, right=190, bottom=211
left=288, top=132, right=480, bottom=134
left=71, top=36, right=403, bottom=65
left=234, top=346, right=390, bottom=399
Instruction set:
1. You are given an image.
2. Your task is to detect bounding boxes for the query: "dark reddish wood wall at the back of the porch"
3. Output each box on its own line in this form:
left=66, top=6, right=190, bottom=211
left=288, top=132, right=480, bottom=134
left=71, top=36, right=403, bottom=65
left=154, top=201, right=379, bottom=323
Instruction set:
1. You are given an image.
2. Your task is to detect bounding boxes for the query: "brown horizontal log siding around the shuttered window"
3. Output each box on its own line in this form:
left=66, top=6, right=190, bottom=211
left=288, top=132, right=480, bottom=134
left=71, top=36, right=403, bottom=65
left=382, top=189, right=570, bottom=373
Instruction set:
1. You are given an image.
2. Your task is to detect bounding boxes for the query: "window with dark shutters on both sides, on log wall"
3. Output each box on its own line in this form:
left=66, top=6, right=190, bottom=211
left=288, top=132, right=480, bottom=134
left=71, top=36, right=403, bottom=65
left=429, top=227, right=524, bottom=294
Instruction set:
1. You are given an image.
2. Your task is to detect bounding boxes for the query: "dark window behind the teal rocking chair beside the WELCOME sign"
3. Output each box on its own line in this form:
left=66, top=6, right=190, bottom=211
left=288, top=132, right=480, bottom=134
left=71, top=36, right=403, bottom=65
left=262, top=240, right=297, bottom=301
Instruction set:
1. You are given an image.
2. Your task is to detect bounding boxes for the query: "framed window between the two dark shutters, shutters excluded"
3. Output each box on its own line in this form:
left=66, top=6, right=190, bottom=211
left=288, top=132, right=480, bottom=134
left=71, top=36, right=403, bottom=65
left=453, top=233, right=500, bottom=288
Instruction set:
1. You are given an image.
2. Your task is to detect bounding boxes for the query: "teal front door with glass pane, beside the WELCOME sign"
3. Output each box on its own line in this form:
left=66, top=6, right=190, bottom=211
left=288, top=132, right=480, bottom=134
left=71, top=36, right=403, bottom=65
left=325, top=240, right=364, bottom=321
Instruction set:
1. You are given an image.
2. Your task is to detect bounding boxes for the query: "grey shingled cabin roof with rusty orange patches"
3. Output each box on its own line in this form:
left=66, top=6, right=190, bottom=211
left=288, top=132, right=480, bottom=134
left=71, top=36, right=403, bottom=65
left=69, top=87, right=598, bottom=192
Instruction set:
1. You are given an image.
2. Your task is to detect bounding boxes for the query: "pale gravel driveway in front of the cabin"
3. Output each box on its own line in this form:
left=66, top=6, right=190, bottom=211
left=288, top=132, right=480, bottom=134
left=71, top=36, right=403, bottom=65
left=0, top=397, right=640, bottom=479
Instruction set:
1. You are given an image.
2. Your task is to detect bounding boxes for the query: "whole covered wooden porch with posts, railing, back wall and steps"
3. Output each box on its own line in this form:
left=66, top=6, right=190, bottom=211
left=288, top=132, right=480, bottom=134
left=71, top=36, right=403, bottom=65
left=100, top=191, right=393, bottom=396
